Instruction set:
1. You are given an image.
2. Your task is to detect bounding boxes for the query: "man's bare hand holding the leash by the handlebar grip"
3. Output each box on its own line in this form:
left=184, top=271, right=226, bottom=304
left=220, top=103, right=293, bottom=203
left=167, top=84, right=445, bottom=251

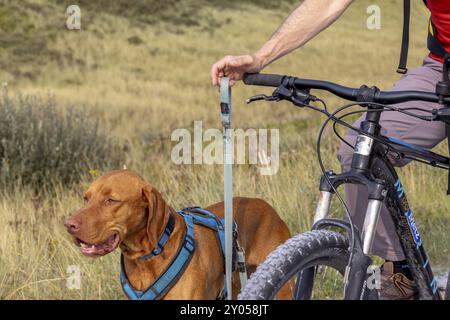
left=211, top=54, right=263, bottom=87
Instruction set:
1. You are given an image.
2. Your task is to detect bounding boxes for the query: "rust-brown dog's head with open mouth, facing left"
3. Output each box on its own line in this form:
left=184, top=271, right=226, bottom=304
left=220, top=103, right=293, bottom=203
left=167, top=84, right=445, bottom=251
left=64, top=170, right=168, bottom=257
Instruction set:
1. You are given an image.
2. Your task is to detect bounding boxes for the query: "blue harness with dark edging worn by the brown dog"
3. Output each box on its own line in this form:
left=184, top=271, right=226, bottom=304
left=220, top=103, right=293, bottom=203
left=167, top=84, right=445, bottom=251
left=120, top=207, right=237, bottom=300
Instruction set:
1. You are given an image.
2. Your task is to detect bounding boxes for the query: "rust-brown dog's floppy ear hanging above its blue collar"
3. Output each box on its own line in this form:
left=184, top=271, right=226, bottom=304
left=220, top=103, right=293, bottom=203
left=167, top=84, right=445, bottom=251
left=142, top=183, right=169, bottom=249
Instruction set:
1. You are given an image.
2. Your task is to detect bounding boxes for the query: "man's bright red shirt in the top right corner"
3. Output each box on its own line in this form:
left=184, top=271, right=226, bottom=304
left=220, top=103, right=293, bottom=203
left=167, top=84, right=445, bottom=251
left=427, top=0, right=450, bottom=63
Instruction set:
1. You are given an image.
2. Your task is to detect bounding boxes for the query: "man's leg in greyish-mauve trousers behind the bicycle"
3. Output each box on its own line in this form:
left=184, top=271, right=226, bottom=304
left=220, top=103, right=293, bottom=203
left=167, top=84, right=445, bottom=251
left=338, top=57, right=446, bottom=296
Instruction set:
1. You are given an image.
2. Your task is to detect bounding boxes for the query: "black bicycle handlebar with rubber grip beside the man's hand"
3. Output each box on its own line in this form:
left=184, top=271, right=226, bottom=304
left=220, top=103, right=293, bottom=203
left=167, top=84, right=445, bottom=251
left=243, top=73, right=450, bottom=104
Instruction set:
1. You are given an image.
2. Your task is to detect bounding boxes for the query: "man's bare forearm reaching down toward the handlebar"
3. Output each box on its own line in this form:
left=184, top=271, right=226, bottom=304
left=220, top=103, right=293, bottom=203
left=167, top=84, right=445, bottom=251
left=255, top=0, right=353, bottom=66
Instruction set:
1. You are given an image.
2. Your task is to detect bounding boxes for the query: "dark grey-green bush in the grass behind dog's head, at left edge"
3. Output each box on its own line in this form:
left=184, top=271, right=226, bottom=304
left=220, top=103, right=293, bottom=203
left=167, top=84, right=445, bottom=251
left=0, top=92, right=123, bottom=190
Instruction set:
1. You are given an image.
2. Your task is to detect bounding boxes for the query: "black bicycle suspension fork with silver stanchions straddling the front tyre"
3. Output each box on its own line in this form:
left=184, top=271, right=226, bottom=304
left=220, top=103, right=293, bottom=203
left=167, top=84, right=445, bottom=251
left=295, top=112, right=387, bottom=300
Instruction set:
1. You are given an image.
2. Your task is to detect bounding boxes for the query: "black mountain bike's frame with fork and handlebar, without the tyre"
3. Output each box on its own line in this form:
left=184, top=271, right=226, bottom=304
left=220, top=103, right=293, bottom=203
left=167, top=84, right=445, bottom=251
left=243, top=67, right=450, bottom=299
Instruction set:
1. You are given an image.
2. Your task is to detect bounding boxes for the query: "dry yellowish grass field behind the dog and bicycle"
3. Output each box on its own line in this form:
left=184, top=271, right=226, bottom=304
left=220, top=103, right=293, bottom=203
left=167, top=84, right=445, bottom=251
left=0, top=0, right=450, bottom=299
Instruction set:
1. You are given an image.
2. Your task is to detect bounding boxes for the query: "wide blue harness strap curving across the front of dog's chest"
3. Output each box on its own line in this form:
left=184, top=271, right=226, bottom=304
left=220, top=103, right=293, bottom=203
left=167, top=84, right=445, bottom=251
left=120, top=215, right=195, bottom=300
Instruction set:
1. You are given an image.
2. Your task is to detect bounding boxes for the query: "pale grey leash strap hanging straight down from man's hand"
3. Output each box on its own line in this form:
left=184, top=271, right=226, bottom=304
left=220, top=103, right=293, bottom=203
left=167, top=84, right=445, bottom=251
left=220, top=77, right=233, bottom=300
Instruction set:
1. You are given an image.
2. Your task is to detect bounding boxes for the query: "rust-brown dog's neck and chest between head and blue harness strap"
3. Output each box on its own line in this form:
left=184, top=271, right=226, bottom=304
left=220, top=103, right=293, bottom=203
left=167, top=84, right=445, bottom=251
left=120, top=206, right=186, bottom=291
